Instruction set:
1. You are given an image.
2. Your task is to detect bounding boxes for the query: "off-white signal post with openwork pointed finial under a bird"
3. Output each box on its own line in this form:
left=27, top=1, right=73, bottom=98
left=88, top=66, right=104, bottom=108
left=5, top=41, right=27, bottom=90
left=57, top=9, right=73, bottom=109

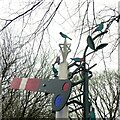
left=56, top=39, right=71, bottom=119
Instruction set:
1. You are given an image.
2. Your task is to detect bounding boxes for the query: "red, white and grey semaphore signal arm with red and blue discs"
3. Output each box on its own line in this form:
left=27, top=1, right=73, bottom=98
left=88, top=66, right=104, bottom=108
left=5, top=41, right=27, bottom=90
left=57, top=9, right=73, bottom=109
left=10, top=78, right=71, bottom=111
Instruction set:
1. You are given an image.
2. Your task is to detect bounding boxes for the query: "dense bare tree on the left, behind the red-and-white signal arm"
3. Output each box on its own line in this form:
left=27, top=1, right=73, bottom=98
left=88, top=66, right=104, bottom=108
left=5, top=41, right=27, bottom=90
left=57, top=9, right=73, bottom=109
left=0, top=28, right=54, bottom=118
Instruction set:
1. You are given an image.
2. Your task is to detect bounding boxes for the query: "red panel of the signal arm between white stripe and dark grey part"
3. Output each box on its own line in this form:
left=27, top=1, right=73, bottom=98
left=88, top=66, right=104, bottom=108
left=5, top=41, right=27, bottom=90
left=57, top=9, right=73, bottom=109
left=25, top=78, right=40, bottom=91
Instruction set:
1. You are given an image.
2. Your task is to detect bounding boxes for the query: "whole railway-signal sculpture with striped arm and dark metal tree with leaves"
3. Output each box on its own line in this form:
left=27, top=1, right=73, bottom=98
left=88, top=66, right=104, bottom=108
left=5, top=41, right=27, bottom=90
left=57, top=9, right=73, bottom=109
left=11, top=29, right=108, bottom=119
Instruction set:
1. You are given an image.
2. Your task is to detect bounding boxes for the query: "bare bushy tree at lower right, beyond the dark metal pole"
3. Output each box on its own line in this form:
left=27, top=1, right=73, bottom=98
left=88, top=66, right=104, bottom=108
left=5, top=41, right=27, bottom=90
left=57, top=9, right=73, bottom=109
left=89, top=71, right=120, bottom=120
